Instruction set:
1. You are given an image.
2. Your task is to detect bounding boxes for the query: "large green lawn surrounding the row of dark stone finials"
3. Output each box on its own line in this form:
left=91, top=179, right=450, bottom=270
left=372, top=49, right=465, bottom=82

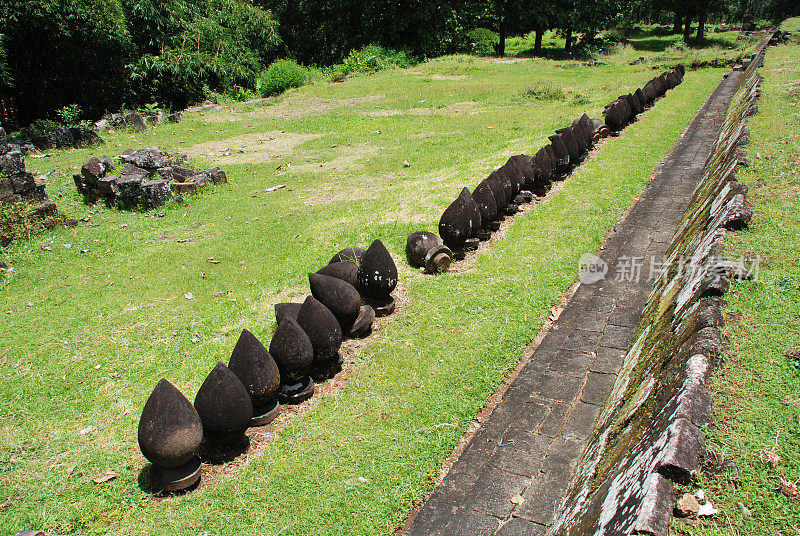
left=0, top=30, right=756, bottom=535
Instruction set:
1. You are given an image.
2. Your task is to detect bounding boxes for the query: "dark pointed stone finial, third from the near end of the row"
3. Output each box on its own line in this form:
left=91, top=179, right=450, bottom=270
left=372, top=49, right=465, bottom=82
left=228, top=329, right=281, bottom=426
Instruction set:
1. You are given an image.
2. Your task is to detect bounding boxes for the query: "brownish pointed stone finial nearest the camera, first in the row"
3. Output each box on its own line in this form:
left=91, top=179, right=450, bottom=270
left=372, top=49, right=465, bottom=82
left=138, top=379, right=203, bottom=491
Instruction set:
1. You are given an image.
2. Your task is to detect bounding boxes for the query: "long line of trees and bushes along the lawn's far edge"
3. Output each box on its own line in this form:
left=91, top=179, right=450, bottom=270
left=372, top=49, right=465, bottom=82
left=0, top=0, right=800, bottom=127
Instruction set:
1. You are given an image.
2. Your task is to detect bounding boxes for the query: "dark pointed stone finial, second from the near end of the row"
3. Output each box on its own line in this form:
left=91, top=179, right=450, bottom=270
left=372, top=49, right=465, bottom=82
left=194, top=362, right=253, bottom=447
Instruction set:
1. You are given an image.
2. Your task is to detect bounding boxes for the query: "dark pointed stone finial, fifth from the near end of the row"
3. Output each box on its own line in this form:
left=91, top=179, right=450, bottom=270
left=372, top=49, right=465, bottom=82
left=297, top=296, right=342, bottom=381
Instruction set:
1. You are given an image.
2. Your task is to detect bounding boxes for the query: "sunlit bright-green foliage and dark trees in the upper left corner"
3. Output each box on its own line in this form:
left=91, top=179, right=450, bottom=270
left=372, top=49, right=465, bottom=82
left=0, top=0, right=280, bottom=124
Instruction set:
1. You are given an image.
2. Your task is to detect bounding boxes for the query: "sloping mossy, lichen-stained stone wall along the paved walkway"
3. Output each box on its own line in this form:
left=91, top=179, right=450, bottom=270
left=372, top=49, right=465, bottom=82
left=550, top=37, right=766, bottom=536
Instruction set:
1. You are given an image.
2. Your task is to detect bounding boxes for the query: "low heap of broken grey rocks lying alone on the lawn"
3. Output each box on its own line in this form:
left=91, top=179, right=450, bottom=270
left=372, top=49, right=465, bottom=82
left=73, top=148, right=228, bottom=208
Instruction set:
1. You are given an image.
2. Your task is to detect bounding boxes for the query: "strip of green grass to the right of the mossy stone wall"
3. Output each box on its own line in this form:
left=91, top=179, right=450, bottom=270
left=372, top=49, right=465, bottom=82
left=680, top=19, right=800, bottom=536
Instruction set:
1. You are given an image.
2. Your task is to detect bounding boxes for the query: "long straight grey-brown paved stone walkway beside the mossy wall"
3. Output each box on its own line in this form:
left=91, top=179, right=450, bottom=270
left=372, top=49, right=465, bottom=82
left=405, top=72, right=742, bottom=536
